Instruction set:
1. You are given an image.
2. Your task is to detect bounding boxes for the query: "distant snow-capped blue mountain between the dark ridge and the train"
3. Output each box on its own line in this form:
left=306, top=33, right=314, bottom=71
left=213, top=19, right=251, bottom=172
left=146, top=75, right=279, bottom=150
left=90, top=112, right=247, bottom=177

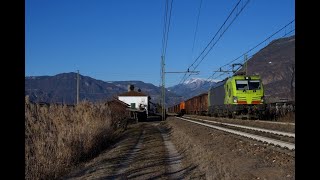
left=168, top=78, right=220, bottom=99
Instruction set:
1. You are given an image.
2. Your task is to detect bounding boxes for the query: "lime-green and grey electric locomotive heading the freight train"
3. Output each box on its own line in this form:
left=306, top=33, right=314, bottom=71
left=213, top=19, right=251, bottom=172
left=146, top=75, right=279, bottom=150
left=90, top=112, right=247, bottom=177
left=208, top=75, right=265, bottom=119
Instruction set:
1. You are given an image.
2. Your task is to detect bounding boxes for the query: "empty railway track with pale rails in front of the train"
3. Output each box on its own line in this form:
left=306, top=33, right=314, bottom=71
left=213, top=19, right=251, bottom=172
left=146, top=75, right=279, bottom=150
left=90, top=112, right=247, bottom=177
left=177, top=117, right=295, bottom=150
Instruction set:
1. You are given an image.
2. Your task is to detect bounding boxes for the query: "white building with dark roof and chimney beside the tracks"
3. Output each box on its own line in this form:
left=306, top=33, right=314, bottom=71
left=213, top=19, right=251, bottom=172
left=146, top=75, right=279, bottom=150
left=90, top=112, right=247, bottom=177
left=118, top=85, right=149, bottom=114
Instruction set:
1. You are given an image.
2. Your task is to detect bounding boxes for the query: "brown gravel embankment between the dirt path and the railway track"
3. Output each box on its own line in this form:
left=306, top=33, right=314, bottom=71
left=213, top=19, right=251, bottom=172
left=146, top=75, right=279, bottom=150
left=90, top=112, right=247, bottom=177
left=168, top=117, right=295, bottom=179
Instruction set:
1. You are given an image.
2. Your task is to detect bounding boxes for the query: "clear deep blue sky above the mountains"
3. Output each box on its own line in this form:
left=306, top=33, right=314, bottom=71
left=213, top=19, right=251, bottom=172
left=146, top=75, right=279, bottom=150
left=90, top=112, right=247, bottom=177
left=25, top=0, right=295, bottom=87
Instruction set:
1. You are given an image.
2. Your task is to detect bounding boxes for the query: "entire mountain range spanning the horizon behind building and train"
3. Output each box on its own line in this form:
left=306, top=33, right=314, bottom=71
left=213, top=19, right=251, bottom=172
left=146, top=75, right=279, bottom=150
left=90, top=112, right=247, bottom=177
left=25, top=35, right=295, bottom=107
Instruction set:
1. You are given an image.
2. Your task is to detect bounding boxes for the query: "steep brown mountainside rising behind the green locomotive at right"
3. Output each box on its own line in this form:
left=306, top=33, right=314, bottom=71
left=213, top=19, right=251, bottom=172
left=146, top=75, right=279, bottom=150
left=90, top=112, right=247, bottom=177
left=239, top=35, right=295, bottom=102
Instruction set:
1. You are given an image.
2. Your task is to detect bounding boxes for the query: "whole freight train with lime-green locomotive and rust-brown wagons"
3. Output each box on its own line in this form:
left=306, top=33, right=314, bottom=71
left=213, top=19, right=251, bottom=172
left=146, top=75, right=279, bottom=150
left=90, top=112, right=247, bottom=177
left=168, top=75, right=266, bottom=119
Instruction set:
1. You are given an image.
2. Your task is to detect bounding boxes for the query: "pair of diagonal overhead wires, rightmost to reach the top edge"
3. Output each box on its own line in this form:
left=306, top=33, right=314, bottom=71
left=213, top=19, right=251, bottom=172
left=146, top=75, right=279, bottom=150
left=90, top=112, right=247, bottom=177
left=179, top=0, right=250, bottom=84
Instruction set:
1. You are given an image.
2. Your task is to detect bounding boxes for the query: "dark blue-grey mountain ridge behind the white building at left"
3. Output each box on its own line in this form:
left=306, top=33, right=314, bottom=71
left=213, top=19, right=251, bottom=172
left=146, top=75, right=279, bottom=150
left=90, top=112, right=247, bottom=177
left=25, top=72, right=182, bottom=105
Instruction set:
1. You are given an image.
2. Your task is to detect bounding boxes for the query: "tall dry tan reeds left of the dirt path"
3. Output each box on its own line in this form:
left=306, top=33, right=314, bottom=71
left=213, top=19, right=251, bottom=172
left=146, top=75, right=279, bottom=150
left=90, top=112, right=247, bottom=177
left=25, top=99, right=127, bottom=179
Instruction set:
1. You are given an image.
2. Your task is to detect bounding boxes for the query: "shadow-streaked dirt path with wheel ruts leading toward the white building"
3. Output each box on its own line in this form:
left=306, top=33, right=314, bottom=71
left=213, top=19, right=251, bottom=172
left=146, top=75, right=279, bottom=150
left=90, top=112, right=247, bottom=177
left=62, top=122, right=195, bottom=179
